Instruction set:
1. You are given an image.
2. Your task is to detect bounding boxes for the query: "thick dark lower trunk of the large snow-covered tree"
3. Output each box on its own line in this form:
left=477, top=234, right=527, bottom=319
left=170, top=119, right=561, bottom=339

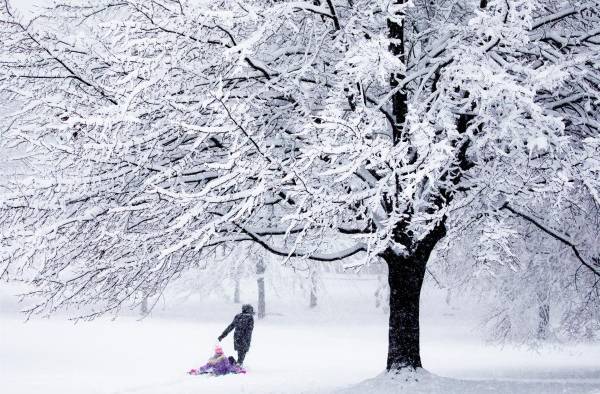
left=383, top=223, right=446, bottom=372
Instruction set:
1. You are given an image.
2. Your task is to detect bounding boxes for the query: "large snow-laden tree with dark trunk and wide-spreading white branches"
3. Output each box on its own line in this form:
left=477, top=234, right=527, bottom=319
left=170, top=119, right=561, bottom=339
left=0, top=0, right=600, bottom=371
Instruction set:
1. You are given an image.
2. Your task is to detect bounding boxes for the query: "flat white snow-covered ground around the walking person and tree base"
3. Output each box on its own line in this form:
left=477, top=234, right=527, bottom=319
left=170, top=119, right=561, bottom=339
left=0, top=277, right=600, bottom=394
